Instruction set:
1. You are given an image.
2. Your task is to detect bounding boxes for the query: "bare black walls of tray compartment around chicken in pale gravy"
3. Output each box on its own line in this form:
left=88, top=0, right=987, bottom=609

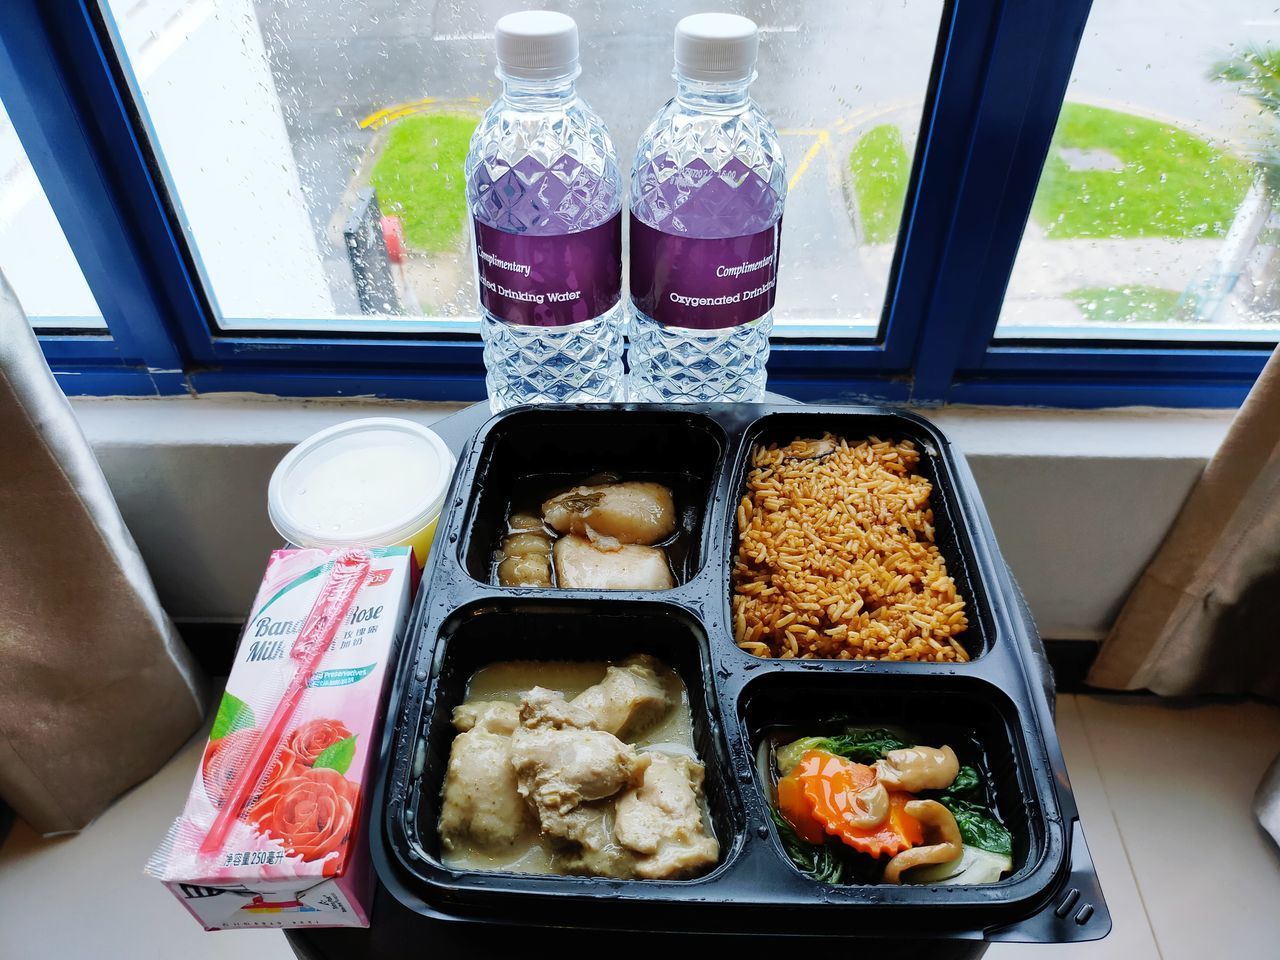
left=397, top=598, right=744, bottom=896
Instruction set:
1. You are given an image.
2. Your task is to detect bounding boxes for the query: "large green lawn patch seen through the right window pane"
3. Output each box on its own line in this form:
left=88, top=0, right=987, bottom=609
left=1032, top=104, right=1252, bottom=239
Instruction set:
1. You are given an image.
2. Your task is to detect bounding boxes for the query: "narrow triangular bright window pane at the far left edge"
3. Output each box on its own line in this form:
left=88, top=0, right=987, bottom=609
left=0, top=97, right=106, bottom=333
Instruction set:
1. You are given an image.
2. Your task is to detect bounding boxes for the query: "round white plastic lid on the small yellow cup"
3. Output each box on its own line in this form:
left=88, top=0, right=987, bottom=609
left=266, top=417, right=454, bottom=547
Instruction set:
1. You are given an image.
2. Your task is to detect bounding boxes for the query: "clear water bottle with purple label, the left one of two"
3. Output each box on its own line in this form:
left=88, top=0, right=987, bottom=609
left=466, top=10, right=626, bottom=412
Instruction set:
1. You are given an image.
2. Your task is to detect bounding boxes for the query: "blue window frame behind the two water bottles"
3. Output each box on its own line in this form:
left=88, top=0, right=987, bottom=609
left=0, top=0, right=1271, bottom=407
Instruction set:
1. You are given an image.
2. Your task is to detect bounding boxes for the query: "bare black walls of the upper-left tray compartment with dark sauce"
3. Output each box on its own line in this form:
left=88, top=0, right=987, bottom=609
left=460, top=408, right=727, bottom=584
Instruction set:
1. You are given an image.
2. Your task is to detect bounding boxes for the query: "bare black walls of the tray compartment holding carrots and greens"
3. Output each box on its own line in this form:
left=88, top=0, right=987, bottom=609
left=740, top=673, right=1051, bottom=902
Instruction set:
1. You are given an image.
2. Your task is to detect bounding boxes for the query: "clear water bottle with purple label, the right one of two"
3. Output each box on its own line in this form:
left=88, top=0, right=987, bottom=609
left=631, top=13, right=787, bottom=403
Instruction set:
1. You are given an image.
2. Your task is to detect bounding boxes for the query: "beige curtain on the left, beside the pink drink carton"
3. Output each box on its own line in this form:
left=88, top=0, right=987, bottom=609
left=0, top=274, right=205, bottom=833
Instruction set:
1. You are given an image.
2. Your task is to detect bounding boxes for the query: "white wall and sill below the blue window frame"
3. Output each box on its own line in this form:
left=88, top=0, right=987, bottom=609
left=73, top=398, right=1229, bottom=640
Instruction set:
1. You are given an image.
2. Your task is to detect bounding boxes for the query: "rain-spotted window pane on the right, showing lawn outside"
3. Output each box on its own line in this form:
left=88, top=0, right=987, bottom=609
left=996, top=0, right=1280, bottom=340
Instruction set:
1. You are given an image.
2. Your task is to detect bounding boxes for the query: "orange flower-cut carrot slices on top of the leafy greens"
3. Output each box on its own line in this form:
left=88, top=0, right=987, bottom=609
left=778, top=750, right=924, bottom=856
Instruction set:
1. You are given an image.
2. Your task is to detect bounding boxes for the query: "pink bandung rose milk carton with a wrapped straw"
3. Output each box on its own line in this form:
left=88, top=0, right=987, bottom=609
left=146, top=547, right=417, bottom=931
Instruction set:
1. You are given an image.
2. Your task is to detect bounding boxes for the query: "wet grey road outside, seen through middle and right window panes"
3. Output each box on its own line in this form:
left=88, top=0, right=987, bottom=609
left=257, top=0, right=1280, bottom=320
